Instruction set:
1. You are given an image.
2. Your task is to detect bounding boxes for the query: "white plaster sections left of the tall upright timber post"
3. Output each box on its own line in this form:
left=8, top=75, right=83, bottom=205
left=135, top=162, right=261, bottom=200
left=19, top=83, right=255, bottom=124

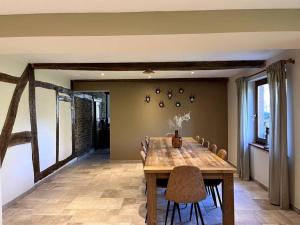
left=0, top=57, right=33, bottom=207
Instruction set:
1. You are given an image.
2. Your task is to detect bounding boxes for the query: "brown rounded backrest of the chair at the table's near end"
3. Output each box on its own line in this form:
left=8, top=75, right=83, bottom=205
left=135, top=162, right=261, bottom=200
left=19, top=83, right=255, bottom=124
left=166, top=166, right=206, bottom=203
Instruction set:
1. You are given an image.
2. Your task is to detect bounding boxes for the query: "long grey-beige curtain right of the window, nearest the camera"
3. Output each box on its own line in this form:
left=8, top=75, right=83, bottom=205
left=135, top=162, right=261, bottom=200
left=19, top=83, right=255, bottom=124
left=267, top=61, right=290, bottom=209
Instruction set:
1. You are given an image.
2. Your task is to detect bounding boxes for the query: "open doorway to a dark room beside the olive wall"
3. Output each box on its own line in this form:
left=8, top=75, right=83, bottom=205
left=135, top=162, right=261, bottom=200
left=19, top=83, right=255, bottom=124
left=75, top=92, right=110, bottom=158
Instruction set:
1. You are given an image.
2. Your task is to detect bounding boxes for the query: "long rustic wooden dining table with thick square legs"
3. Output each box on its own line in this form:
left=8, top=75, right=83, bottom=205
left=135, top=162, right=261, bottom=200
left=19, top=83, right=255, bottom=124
left=144, top=137, right=236, bottom=225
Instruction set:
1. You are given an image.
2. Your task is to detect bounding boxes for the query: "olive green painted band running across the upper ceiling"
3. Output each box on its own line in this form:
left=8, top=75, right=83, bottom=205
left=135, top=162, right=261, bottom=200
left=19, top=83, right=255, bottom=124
left=0, top=9, right=300, bottom=37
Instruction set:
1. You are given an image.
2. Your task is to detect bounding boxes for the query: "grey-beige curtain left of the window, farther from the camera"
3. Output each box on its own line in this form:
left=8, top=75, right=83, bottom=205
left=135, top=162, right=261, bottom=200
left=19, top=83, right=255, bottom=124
left=236, top=77, right=250, bottom=180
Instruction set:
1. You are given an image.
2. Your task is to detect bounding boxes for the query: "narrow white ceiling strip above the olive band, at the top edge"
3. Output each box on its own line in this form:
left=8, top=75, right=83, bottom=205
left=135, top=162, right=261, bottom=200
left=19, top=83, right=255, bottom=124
left=0, top=0, right=300, bottom=15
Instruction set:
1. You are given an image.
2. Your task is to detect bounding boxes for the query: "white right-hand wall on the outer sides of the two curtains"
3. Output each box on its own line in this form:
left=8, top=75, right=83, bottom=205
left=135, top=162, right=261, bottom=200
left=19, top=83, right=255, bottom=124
left=228, top=50, right=300, bottom=209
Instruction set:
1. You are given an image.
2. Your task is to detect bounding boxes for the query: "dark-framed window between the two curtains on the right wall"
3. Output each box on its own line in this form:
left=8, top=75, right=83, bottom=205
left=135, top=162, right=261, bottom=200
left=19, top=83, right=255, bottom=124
left=255, top=79, right=271, bottom=145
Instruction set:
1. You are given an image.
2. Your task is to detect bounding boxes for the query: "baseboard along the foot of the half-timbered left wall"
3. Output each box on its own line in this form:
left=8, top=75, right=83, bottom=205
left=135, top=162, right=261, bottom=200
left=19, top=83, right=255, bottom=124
left=2, top=158, right=78, bottom=211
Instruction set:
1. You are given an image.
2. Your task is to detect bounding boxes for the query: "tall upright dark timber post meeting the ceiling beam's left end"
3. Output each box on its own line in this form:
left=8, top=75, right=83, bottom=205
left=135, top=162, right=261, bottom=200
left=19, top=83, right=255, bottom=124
left=29, top=66, right=40, bottom=182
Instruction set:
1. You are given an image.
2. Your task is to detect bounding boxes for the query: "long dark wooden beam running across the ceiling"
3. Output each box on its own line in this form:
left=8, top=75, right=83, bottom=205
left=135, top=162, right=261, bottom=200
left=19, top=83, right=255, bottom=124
left=33, top=60, right=266, bottom=71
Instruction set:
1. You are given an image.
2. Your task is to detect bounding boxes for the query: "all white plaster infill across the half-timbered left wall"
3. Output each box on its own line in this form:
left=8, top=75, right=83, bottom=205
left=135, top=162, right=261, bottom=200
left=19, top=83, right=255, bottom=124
left=0, top=56, right=71, bottom=209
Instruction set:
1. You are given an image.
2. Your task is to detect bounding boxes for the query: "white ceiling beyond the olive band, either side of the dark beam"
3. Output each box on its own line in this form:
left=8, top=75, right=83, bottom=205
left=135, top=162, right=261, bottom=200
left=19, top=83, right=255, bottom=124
left=0, top=32, right=300, bottom=79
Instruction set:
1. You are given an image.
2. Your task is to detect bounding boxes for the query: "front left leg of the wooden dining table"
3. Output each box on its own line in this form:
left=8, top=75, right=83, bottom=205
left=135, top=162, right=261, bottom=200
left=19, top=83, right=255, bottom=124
left=146, top=173, right=157, bottom=225
